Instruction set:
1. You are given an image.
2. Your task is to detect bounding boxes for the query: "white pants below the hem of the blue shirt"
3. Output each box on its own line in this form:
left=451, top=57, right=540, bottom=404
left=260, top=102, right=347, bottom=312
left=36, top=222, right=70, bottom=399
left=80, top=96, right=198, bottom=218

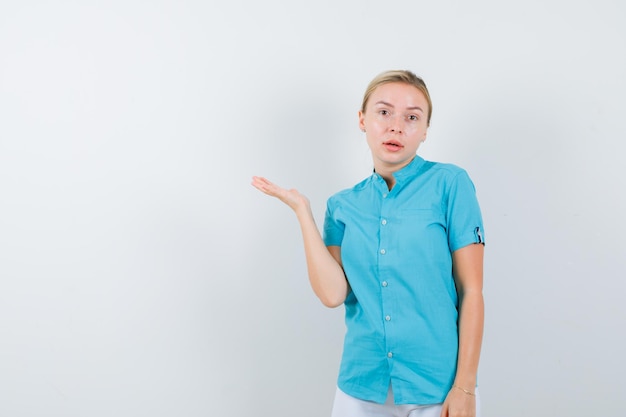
left=331, top=386, right=480, bottom=417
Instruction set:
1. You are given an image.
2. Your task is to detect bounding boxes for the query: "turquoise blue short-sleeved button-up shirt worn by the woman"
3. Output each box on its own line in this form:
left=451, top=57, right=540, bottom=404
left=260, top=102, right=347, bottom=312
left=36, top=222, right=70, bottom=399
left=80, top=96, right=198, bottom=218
left=324, top=156, right=483, bottom=404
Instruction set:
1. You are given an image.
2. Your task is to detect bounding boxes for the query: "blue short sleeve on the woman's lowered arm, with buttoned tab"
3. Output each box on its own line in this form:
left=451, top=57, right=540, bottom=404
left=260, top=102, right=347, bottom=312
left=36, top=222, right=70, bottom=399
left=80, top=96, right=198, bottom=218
left=446, top=171, right=485, bottom=252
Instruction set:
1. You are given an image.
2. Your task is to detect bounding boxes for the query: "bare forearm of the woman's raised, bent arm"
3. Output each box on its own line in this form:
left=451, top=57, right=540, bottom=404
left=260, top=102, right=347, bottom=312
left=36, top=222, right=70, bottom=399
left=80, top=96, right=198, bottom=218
left=296, top=207, right=348, bottom=307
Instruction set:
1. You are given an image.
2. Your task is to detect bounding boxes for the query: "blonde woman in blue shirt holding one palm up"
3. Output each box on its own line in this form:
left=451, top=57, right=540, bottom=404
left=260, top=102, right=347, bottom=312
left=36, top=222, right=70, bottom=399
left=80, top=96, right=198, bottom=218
left=252, top=71, right=484, bottom=417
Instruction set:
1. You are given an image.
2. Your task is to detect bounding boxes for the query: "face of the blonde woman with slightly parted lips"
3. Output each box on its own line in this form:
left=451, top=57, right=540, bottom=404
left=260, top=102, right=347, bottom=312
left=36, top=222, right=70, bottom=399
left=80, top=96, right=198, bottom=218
left=359, top=83, right=428, bottom=175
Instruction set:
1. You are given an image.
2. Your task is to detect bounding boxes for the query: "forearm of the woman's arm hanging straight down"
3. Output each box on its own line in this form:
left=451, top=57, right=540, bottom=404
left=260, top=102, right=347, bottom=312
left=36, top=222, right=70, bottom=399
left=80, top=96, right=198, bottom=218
left=454, top=289, right=484, bottom=392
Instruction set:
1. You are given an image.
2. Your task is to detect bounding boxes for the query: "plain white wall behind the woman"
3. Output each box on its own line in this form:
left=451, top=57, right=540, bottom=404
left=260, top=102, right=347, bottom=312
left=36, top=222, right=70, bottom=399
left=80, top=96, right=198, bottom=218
left=0, top=0, right=626, bottom=417
